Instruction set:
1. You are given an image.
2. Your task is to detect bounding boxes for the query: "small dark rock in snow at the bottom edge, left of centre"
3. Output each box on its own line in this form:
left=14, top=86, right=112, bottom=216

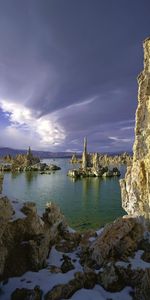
left=11, top=286, right=42, bottom=300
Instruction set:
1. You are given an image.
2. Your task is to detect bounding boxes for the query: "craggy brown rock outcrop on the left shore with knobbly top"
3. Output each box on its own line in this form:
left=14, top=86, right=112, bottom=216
left=0, top=196, right=66, bottom=280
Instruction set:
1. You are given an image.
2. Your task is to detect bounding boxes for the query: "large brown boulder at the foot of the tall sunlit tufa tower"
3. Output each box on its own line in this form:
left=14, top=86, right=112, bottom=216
left=90, top=217, right=143, bottom=265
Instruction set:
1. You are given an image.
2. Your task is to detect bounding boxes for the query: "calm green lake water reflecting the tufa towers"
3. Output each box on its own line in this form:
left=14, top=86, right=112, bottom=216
left=3, top=159, right=126, bottom=230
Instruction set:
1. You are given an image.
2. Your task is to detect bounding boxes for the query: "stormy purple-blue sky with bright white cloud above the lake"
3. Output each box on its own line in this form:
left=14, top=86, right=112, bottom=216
left=0, top=0, right=150, bottom=152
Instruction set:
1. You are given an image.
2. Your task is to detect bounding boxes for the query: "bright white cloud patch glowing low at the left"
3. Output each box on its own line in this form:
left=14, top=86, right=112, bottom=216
left=0, top=100, right=66, bottom=149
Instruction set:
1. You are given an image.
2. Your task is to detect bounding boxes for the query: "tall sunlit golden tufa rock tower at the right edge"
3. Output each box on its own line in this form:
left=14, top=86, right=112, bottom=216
left=120, top=38, right=150, bottom=220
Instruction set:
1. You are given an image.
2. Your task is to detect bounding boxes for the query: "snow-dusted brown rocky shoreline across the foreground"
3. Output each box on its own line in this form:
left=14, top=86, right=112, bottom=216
left=0, top=186, right=150, bottom=300
